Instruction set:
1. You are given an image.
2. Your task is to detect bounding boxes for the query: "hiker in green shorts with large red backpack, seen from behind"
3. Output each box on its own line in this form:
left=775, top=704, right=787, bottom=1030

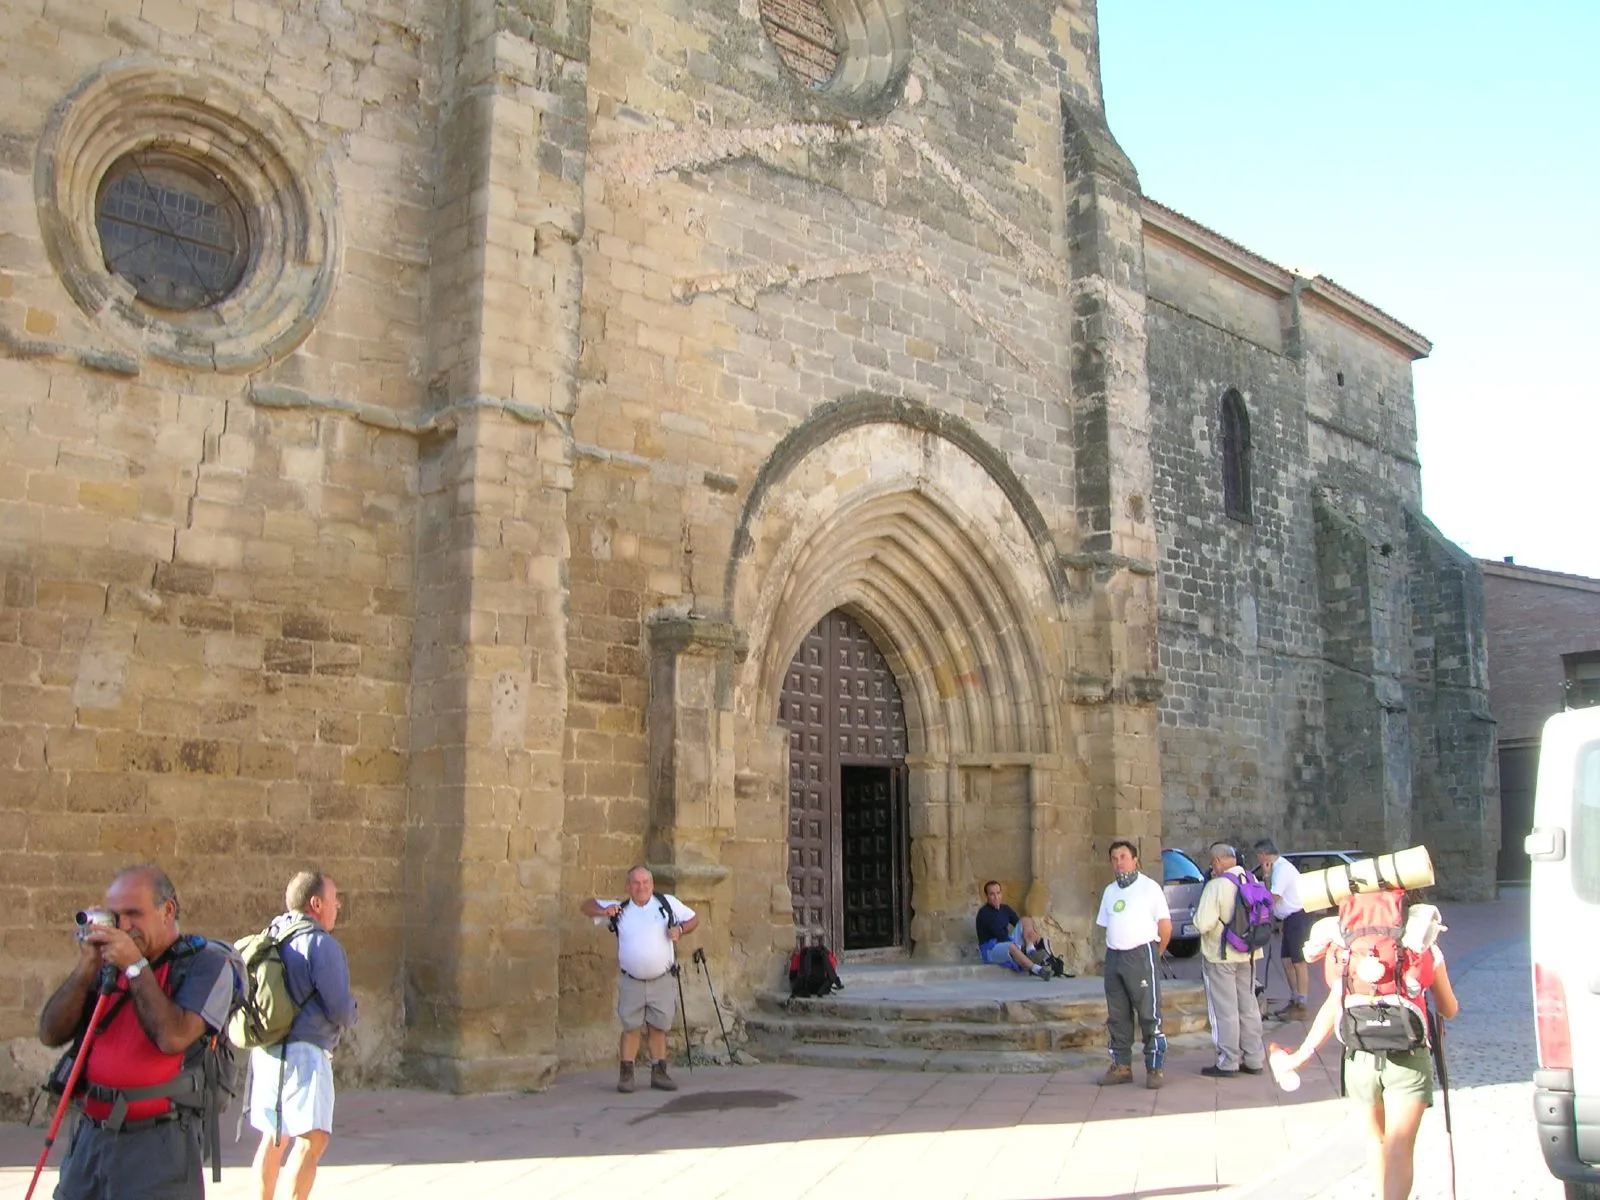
left=1270, top=888, right=1461, bottom=1200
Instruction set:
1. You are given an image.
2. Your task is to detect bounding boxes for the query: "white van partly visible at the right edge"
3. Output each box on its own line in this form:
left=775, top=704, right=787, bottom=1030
left=1523, top=707, right=1600, bottom=1200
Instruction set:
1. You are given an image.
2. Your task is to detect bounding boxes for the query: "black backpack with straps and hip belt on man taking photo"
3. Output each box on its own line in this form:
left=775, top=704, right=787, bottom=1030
left=45, top=934, right=245, bottom=1184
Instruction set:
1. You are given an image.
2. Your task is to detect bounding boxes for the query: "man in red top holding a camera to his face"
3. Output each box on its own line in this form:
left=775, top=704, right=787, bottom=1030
left=38, top=866, right=238, bottom=1200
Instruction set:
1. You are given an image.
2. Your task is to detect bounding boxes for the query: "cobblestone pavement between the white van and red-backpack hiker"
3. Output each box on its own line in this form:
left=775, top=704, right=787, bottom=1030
left=1286, top=908, right=1563, bottom=1200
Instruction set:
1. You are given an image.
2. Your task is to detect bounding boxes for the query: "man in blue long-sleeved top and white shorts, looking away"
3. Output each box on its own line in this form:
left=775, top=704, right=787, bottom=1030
left=250, top=870, right=355, bottom=1200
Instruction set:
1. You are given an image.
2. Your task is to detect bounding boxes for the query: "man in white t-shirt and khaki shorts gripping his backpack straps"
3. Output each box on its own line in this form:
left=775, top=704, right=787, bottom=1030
left=582, top=867, right=699, bottom=1091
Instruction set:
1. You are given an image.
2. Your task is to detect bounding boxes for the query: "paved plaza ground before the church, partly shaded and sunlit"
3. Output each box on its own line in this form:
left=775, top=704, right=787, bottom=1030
left=0, top=893, right=1562, bottom=1200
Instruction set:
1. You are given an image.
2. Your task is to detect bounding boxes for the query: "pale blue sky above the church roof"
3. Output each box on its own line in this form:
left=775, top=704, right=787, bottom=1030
left=1099, top=0, right=1600, bottom=578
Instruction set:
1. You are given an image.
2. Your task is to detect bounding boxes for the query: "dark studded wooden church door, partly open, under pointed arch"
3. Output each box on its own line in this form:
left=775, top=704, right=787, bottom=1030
left=779, top=608, right=910, bottom=950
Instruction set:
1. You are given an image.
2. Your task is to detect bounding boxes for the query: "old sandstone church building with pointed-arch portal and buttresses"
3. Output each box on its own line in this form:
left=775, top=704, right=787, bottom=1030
left=0, top=0, right=1498, bottom=1093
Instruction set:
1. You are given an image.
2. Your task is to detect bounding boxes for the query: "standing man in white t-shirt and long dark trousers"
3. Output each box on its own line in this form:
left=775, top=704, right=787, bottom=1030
left=1096, top=840, right=1173, bottom=1088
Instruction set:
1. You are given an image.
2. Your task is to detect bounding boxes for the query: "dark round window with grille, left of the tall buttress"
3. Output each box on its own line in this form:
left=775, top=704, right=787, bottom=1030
left=94, top=150, right=250, bottom=312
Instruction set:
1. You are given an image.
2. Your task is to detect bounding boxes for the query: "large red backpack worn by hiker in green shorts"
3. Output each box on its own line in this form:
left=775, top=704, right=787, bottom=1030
left=1326, top=888, right=1434, bottom=1054
